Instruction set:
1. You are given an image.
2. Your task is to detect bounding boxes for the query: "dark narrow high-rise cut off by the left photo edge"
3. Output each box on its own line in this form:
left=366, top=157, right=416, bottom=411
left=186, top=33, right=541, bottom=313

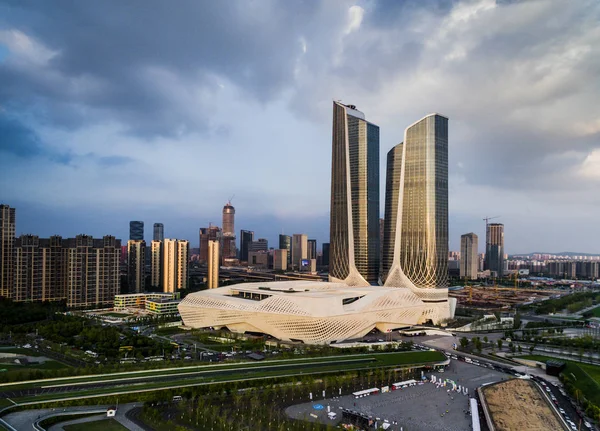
left=0, top=204, right=16, bottom=298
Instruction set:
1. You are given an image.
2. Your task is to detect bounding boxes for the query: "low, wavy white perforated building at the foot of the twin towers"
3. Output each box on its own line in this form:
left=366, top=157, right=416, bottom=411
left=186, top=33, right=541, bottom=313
left=179, top=281, right=454, bottom=344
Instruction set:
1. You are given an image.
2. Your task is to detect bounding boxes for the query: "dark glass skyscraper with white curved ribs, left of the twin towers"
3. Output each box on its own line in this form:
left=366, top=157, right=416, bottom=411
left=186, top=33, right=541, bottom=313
left=328, top=102, right=379, bottom=286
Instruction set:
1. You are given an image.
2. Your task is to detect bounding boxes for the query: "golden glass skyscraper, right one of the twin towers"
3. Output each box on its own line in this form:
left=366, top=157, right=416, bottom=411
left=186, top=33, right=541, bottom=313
left=384, top=114, right=448, bottom=288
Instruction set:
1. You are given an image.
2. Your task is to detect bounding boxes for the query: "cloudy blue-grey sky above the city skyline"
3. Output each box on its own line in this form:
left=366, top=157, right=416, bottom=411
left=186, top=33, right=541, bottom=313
left=0, top=0, right=600, bottom=253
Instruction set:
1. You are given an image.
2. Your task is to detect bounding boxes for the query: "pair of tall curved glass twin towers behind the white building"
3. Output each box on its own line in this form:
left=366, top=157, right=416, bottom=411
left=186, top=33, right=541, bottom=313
left=329, top=102, right=448, bottom=292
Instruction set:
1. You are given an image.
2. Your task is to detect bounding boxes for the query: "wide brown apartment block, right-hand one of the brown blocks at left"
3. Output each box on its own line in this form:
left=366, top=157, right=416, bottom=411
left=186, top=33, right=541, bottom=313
left=63, top=235, right=121, bottom=308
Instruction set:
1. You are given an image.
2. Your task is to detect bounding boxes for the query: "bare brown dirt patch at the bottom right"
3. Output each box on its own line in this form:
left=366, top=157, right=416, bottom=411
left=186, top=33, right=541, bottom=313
left=483, top=379, right=564, bottom=431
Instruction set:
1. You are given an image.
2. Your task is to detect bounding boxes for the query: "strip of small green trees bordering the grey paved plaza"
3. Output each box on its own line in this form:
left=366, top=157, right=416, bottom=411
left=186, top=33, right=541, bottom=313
left=142, top=368, right=420, bottom=431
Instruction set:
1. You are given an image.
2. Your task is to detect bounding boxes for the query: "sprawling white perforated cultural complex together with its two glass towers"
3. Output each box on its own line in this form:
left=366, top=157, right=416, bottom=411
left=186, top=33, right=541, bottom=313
left=179, top=102, right=456, bottom=344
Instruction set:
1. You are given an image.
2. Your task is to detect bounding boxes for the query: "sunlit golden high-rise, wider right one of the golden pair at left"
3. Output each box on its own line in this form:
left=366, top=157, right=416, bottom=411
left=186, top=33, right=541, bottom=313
left=161, top=238, right=189, bottom=293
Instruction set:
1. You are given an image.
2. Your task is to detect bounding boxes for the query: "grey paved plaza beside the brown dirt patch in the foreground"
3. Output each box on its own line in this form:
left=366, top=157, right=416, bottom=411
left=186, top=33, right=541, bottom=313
left=286, top=360, right=508, bottom=431
